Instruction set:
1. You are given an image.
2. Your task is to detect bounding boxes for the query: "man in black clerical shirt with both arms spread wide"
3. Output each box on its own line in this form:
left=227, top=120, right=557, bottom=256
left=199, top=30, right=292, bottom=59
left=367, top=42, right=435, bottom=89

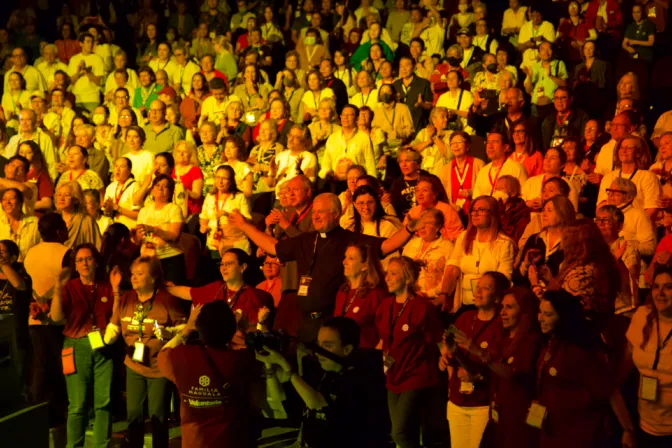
left=229, top=193, right=417, bottom=341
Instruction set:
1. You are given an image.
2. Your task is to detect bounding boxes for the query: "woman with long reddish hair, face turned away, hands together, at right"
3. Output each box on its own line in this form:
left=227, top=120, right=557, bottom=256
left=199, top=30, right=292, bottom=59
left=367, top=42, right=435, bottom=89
left=528, top=219, right=621, bottom=317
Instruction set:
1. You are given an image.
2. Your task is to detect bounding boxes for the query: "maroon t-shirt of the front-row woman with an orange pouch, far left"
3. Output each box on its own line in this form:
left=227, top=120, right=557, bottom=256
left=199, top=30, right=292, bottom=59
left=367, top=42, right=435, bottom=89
left=63, top=278, right=114, bottom=339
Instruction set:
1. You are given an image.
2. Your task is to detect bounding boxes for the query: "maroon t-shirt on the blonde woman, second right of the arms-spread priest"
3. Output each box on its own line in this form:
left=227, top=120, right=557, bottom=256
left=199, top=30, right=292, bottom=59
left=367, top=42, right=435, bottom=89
left=376, top=295, right=443, bottom=394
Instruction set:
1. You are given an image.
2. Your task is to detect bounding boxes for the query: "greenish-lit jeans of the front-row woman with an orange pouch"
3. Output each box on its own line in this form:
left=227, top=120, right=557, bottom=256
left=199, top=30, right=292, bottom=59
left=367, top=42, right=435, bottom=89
left=63, top=337, right=112, bottom=448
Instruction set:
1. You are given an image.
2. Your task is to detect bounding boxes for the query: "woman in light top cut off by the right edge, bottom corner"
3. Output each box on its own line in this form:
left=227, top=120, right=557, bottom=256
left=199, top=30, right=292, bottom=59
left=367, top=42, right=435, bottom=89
left=624, top=266, right=672, bottom=448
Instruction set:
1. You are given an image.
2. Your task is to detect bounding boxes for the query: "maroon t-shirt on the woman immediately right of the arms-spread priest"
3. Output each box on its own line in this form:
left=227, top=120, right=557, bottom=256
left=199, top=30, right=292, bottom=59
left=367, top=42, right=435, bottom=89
left=334, top=288, right=386, bottom=348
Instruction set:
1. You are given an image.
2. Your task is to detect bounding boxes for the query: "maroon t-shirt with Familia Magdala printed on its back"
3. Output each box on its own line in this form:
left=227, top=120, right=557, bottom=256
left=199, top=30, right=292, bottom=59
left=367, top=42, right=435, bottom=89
left=158, top=345, right=261, bottom=448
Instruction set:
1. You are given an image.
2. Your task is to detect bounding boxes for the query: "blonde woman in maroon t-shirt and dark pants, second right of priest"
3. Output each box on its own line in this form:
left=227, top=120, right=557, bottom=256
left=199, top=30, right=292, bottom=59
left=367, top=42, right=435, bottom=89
left=376, top=257, right=443, bottom=448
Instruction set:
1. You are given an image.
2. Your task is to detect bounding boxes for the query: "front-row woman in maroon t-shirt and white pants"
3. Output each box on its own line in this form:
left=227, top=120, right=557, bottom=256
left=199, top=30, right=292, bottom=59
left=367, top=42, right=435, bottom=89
left=439, top=271, right=510, bottom=448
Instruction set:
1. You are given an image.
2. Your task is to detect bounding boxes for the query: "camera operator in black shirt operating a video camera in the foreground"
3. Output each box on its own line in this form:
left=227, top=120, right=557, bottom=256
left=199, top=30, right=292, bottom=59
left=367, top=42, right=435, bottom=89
left=257, top=317, right=389, bottom=448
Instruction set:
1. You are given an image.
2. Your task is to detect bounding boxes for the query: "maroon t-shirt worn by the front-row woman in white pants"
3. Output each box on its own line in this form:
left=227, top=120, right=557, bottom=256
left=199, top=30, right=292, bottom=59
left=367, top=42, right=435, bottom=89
left=448, top=310, right=502, bottom=407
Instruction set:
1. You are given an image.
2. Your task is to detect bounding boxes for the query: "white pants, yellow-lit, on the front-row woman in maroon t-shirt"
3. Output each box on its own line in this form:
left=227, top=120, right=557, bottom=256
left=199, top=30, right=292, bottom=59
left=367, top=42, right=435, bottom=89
left=448, top=401, right=490, bottom=448
